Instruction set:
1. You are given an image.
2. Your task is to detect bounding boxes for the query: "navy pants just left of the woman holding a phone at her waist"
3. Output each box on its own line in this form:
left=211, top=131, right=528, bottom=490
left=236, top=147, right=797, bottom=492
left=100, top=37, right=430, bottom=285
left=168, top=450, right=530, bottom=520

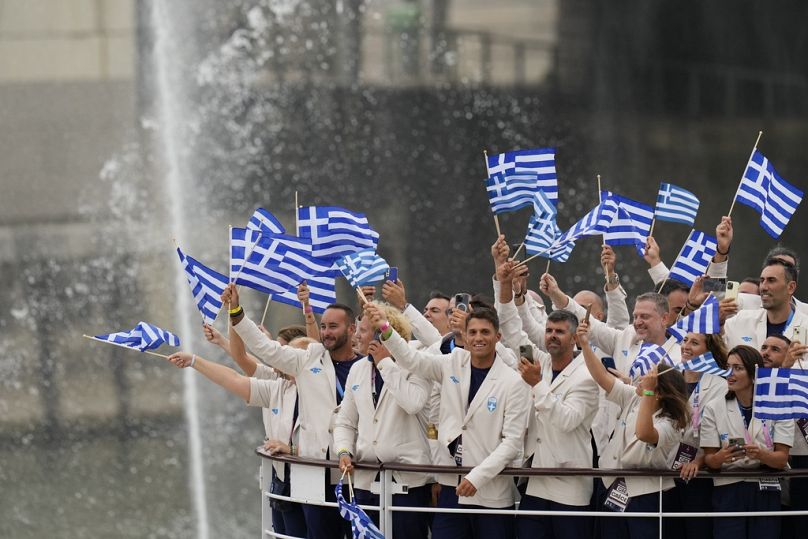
left=662, top=478, right=713, bottom=539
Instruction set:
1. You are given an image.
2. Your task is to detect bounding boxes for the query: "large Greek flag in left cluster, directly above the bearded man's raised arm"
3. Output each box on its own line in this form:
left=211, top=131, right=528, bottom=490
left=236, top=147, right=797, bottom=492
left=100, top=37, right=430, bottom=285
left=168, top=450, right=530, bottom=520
left=230, top=228, right=337, bottom=313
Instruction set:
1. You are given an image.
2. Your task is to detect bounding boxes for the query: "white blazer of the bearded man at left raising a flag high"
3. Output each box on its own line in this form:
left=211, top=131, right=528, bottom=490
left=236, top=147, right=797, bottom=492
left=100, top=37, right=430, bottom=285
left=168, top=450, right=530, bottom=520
left=233, top=316, right=340, bottom=484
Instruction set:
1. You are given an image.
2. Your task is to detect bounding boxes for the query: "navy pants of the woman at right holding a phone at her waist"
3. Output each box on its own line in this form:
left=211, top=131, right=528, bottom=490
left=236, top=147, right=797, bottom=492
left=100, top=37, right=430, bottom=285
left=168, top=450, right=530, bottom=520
left=713, top=481, right=780, bottom=539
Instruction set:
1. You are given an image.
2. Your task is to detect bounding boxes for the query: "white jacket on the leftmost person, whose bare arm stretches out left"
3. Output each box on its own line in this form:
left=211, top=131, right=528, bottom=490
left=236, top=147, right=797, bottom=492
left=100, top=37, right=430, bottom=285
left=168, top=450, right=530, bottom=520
left=247, top=378, right=300, bottom=480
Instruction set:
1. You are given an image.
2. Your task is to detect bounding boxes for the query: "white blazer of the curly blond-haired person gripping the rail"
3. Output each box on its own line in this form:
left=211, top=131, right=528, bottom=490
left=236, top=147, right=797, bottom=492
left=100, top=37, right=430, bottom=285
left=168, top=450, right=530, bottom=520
left=334, top=358, right=432, bottom=490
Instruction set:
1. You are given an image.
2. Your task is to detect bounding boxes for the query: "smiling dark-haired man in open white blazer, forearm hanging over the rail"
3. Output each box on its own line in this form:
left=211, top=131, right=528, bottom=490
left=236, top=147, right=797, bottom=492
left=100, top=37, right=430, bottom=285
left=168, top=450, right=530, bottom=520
left=365, top=304, right=529, bottom=539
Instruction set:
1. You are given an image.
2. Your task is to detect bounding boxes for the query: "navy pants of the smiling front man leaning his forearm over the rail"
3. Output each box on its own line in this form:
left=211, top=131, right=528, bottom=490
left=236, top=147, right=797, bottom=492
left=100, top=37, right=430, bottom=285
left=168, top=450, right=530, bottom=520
left=432, top=485, right=514, bottom=539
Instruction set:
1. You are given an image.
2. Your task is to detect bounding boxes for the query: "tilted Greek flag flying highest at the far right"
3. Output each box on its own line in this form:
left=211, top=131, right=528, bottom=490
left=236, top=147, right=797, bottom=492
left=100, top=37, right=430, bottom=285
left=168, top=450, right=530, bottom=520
left=735, top=150, right=803, bottom=239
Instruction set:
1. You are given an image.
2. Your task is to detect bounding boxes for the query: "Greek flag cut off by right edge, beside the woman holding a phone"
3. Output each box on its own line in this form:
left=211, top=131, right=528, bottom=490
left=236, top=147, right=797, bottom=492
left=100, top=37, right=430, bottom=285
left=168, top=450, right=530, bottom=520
left=752, top=368, right=808, bottom=420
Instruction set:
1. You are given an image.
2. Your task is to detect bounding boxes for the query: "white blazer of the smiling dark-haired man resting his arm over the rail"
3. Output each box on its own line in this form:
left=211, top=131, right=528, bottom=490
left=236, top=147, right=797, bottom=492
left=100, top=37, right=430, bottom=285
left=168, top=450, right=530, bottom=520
left=384, top=331, right=529, bottom=508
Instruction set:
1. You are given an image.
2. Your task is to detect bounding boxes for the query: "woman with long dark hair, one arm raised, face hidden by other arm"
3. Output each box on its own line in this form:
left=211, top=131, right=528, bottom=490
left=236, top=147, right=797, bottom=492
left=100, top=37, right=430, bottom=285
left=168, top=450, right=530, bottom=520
left=577, top=322, right=690, bottom=539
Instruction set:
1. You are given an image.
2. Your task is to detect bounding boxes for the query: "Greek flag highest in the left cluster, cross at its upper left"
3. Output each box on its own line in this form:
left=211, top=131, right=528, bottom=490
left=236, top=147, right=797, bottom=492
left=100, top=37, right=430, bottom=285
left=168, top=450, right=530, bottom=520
left=297, top=206, right=379, bottom=260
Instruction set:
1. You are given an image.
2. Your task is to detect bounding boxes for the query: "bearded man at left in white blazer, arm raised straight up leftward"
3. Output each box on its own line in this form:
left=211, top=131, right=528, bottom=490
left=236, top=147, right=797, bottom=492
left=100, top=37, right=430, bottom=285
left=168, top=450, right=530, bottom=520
left=222, top=283, right=361, bottom=539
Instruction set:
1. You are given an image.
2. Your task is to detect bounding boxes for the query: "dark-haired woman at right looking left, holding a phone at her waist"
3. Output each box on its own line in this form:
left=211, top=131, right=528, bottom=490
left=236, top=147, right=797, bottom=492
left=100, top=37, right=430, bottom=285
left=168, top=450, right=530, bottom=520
left=701, top=345, right=794, bottom=539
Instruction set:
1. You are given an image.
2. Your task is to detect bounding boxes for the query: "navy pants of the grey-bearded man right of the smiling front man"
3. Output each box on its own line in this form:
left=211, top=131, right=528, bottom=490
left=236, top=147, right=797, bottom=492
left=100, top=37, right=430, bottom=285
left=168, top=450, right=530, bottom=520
left=516, top=495, right=592, bottom=539
